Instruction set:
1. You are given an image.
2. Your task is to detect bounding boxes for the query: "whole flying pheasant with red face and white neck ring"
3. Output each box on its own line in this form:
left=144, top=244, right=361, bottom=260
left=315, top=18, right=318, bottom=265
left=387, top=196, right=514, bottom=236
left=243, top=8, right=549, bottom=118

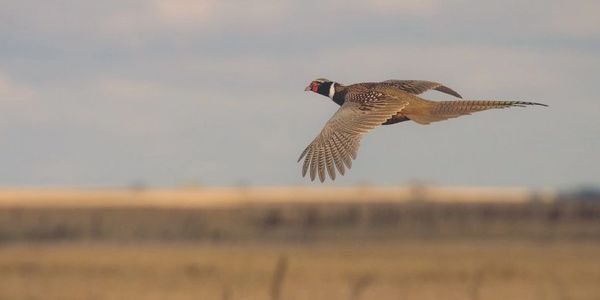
left=298, top=78, right=547, bottom=182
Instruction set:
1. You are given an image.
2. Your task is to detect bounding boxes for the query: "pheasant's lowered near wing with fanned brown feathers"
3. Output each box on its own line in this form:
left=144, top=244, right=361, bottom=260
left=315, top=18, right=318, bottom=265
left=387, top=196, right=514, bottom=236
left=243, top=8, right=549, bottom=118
left=298, top=90, right=407, bottom=182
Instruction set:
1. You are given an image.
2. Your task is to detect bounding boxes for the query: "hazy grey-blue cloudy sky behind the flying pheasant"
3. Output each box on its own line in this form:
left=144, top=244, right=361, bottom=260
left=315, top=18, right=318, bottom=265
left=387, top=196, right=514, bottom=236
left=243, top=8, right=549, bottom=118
left=0, top=0, right=600, bottom=188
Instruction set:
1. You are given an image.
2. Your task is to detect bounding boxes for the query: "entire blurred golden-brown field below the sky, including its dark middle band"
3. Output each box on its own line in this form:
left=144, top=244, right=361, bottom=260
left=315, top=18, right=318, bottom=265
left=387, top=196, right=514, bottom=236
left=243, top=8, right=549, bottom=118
left=0, top=187, right=600, bottom=300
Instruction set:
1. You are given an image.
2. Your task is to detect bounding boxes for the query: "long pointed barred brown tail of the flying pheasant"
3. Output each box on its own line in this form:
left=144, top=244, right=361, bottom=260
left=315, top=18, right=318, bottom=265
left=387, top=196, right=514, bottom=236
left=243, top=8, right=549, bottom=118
left=408, top=100, right=548, bottom=124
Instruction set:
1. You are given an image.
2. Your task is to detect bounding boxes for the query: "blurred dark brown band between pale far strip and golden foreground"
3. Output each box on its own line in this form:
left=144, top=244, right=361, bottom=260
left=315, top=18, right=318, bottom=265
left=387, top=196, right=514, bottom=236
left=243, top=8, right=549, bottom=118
left=0, top=198, right=600, bottom=243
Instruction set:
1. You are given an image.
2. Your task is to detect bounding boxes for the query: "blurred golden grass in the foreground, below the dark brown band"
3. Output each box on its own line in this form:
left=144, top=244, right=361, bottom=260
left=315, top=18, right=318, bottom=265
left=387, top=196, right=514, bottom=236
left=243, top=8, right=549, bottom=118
left=0, top=241, right=600, bottom=300
